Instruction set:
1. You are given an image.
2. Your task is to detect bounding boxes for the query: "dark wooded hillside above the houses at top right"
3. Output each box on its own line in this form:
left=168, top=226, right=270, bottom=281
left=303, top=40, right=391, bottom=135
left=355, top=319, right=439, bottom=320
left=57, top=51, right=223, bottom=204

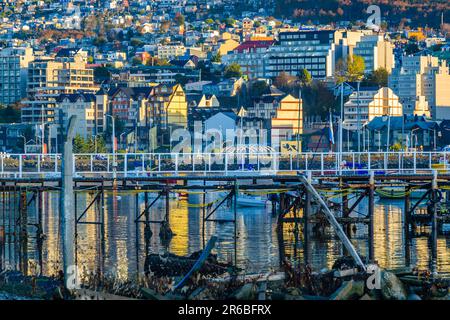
left=275, top=0, right=450, bottom=27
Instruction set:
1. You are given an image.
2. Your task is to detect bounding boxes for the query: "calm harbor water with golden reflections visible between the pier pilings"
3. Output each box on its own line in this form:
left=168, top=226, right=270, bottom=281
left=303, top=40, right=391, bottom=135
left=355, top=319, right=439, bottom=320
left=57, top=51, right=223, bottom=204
left=0, top=192, right=450, bottom=279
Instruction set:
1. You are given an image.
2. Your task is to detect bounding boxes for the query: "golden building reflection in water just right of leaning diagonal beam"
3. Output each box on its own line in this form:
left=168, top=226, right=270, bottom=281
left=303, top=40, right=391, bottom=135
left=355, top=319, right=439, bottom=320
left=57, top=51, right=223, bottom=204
left=374, top=203, right=405, bottom=268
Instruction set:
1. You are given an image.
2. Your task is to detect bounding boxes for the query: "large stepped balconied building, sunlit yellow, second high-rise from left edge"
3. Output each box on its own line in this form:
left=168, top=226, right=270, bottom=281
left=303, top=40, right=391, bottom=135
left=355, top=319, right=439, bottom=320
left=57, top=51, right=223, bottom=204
left=22, top=49, right=99, bottom=124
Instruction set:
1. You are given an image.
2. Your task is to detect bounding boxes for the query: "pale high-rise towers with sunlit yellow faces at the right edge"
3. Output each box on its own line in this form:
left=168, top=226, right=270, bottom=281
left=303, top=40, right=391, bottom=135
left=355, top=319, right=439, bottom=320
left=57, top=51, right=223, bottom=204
left=389, top=56, right=450, bottom=120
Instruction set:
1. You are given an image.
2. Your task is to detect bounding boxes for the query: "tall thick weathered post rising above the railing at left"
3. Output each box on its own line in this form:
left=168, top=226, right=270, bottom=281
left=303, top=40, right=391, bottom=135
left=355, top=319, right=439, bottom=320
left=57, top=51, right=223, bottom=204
left=60, top=116, right=78, bottom=289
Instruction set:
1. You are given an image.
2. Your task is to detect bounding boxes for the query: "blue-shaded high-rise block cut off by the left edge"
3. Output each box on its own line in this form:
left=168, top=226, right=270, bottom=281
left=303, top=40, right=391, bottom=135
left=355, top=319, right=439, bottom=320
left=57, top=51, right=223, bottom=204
left=0, top=47, right=34, bottom=105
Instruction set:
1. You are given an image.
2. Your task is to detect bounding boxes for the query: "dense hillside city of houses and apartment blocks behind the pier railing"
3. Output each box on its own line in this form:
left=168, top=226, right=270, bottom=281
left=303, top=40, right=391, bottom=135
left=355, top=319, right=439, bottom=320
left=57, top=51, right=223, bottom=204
left=0, top=0, right=450, bottom=152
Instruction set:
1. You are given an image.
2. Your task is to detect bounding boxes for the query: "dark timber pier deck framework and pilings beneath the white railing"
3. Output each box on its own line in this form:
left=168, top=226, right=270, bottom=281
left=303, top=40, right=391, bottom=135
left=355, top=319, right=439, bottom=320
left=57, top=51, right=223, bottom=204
left=0, top=162, right=450, bottom=282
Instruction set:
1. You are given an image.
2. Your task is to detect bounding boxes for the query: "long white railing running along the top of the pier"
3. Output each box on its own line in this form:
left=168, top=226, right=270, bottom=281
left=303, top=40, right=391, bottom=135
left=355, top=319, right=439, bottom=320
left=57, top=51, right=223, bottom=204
left=0, top=152, right=450, bottom=177
